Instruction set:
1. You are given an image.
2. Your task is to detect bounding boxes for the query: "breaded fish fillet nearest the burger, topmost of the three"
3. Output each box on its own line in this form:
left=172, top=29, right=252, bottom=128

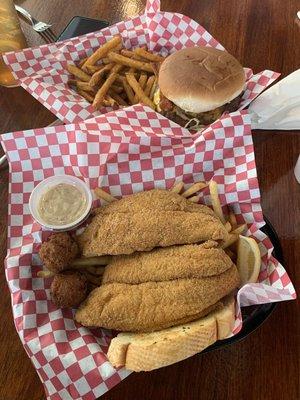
left=78, top=189, right=228, bottom=257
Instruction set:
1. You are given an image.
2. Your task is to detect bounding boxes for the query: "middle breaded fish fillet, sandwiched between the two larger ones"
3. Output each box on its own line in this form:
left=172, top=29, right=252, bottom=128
left=102, top=240, right=232, bottom=284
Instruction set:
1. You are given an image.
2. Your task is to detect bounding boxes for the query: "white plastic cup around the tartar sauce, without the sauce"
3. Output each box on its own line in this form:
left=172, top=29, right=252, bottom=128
left=29, top=175, right=93, bottom=231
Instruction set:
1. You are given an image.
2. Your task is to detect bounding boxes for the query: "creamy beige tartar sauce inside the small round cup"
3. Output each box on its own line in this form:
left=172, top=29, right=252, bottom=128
left=38, top=183, right=87, bottom=225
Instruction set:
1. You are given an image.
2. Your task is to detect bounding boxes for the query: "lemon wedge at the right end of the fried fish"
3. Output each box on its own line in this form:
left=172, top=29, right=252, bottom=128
left=236, top=235, right=261, bottom=286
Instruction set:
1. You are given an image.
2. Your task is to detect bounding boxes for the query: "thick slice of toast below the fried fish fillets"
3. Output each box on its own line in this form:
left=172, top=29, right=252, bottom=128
left=107, top=297, right=235, bottom=372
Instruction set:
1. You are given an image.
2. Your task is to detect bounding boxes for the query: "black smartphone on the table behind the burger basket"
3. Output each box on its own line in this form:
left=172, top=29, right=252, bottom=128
left=56, top=16, right=109, bottom=42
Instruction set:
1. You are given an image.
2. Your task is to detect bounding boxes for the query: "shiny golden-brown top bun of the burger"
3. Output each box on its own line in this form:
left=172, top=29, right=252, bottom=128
left=158, top=47, right=245, bottom=114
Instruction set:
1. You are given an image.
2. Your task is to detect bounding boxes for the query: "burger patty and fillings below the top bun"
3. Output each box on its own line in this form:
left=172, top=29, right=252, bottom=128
left=159, top=92, right=243, bottom=126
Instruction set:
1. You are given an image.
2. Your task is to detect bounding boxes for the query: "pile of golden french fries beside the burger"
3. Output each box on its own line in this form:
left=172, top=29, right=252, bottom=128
left=67, top=36, right=164, bottom=110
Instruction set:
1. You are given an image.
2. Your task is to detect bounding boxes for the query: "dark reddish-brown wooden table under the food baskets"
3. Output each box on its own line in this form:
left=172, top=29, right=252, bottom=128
left=0, top=0, right=300, bottom=400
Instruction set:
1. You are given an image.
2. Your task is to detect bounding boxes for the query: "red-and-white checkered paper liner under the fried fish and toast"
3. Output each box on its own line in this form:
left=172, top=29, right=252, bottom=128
left=1, top=105, right=296, bottom=400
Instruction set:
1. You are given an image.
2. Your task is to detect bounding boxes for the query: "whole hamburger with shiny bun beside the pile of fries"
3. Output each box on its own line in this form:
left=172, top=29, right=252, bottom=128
left=154, top=46, right=245, bottom=130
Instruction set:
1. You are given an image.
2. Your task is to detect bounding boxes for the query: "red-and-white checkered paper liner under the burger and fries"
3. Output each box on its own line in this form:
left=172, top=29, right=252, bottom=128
left=4, top=0, right=279, bottom=123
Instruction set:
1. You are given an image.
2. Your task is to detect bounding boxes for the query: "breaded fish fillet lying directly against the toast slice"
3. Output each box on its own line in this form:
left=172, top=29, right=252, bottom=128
left=75, top=265, right=239, bottom=332
